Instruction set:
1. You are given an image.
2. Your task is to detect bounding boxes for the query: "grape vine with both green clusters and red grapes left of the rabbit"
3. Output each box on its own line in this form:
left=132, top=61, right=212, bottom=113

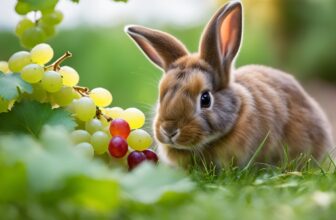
left=0, top=0, right=157, bottom=170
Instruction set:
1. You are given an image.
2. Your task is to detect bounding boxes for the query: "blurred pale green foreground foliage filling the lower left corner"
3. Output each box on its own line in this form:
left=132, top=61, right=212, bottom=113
left=0, top=126, right=193, bottom=219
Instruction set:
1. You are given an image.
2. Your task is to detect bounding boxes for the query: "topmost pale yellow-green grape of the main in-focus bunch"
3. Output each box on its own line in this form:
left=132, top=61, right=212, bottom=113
left=30, top=43, right=54, bottom=65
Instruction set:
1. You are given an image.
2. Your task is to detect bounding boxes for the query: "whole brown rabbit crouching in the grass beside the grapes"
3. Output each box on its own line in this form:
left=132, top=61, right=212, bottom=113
left=126, top=1, right=332, bottom=167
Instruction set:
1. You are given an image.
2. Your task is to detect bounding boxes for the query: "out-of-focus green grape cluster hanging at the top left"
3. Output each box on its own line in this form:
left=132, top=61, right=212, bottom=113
left=15, top=0, right=63, bottom=48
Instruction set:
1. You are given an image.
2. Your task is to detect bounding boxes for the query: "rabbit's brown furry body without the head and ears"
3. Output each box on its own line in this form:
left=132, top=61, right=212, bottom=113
left=159, top=62, right=332, bottom=167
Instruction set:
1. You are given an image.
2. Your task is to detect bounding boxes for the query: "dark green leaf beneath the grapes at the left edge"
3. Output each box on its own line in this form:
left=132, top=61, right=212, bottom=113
left=0, top=101, right=76, bottom=137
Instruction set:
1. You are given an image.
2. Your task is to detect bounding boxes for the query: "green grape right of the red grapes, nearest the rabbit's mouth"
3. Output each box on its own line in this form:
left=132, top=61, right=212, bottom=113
left=127, top=129, right=153, bottom=151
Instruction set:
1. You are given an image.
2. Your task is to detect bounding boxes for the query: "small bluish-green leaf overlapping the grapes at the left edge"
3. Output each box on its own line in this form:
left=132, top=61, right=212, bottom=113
left=0, top=72, right=33, bottom=101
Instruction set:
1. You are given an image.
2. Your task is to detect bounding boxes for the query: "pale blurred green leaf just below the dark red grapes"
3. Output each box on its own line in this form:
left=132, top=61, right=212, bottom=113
left=121, top=163, right=194, bottom=204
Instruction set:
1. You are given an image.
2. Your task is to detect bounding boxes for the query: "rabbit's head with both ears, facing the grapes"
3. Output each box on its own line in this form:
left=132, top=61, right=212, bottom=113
left=125, top=2, right=242, bottom=150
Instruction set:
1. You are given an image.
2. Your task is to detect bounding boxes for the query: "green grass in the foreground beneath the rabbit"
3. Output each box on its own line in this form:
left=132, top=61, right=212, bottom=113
left=121, top=156, right=336, bottom=220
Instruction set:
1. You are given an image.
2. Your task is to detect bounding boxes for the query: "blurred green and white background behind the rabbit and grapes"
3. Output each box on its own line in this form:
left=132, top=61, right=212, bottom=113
left=0, top=0, right=336, bottom=137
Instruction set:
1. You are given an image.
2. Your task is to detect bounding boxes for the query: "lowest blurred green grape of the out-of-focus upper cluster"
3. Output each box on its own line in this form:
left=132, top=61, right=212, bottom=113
left=21, top=27, right=47, bottom=48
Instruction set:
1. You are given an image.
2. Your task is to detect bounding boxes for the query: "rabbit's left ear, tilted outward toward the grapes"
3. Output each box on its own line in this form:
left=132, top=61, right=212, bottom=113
left=125, top=25, right=188, bottom=70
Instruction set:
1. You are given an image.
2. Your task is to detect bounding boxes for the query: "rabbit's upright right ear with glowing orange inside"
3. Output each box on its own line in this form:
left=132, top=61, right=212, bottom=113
left=200, top=1, right=242, bottom=87
